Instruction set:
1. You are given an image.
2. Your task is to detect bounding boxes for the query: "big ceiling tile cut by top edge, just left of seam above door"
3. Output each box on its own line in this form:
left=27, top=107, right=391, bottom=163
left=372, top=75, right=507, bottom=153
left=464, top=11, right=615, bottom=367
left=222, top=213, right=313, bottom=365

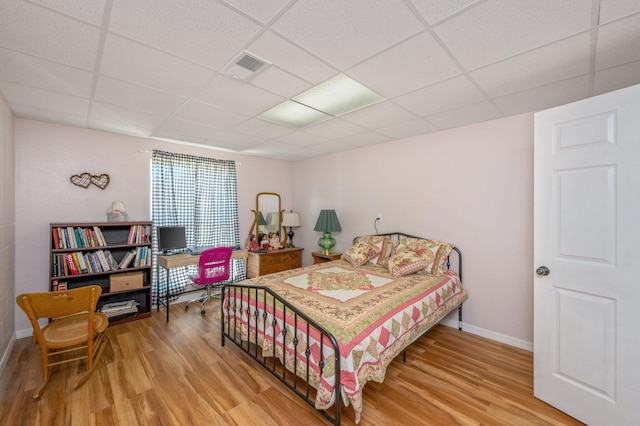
left=435, top=0, right=591, bottom=70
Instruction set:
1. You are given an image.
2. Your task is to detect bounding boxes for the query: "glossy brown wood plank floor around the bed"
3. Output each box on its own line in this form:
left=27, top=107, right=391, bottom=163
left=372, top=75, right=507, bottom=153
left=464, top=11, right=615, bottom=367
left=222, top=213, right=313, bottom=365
left=0, top=301, right=581, bottom=426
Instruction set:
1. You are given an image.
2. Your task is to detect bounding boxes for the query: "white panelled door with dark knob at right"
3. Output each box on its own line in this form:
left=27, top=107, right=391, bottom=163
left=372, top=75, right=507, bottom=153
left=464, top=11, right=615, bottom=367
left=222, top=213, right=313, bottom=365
left=534, top=85, right=640, bottom=426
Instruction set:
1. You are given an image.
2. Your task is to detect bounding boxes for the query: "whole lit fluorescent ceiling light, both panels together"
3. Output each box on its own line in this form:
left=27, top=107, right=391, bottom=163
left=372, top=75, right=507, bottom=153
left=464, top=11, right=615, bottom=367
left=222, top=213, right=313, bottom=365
left=258, top=74, right=385, bottom=129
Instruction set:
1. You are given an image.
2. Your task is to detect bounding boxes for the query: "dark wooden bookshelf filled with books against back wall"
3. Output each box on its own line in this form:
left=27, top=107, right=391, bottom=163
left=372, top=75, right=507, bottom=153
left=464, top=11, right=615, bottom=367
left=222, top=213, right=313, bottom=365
left=49, top=221, right=152, bottom=325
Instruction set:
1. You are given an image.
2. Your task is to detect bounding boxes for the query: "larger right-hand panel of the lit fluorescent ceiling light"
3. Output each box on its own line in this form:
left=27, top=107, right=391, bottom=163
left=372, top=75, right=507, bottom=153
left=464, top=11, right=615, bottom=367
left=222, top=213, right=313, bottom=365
left=292, top=74, right=384, bottom=117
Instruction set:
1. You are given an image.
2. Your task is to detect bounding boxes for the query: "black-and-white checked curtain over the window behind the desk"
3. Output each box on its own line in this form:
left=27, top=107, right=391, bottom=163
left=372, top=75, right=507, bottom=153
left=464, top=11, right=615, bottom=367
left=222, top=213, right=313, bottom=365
left=151, top=150, right=246, bottom=304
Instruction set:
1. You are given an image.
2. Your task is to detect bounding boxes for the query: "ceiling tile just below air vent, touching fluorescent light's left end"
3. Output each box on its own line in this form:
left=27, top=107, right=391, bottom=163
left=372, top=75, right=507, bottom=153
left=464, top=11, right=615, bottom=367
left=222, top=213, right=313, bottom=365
left=196, top=74, right=285, bottom=115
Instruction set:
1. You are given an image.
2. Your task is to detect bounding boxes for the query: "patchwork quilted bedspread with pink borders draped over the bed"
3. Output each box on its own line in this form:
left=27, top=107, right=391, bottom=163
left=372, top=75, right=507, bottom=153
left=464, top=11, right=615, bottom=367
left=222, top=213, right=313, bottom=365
left=225, top=260, right=467, bottom=420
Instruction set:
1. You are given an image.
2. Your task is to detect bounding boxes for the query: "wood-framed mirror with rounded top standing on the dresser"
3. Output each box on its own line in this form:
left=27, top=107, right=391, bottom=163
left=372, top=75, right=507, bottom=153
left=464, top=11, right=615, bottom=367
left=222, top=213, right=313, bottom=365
left=249, top=192, right=287, bottom=248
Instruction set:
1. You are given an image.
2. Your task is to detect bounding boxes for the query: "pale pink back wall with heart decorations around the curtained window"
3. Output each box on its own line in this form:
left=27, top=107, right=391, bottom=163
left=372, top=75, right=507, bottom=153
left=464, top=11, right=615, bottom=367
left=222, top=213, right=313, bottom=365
left=13, top=119, right=293, bottom=330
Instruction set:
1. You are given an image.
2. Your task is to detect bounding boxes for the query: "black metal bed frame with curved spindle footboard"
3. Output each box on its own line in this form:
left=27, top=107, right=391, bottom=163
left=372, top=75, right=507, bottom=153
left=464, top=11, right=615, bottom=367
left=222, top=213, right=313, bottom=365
left=220, top=232, right=462, bottom=425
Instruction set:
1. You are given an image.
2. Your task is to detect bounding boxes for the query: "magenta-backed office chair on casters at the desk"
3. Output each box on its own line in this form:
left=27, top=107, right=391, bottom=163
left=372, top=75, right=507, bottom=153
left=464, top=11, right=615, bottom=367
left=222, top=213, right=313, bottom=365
left=184, top=247, right=231, bottom=315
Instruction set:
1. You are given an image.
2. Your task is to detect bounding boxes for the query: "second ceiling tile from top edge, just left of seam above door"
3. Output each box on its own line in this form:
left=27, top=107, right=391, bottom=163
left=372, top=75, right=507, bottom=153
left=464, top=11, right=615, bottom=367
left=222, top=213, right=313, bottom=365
left=469, top=33, right=591, bottom=96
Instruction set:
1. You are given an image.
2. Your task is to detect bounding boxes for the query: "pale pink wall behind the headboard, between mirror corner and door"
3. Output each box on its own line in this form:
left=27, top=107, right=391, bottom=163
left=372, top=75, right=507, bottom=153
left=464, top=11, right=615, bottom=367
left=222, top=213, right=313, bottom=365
left=294, top=114, right=533, bottom=347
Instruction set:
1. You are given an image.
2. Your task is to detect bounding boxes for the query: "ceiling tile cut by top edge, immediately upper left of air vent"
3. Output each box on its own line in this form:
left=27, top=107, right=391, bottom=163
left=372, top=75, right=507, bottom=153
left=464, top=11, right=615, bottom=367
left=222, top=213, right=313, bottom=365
left=109, top=0, right=260, bottom=69
